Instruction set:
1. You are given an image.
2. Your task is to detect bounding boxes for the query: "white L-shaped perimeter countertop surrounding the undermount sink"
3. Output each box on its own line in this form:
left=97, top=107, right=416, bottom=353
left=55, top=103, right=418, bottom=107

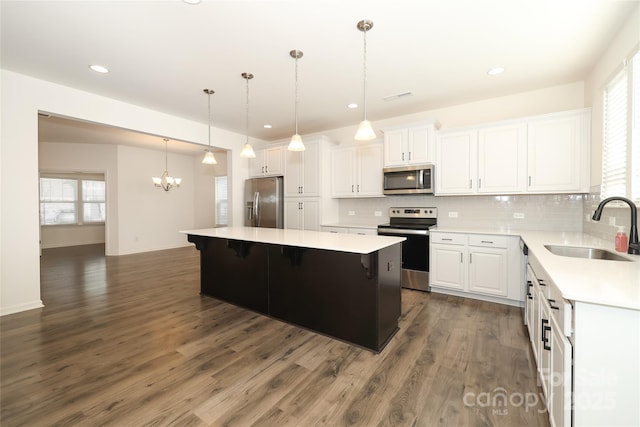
left=437, top=227, right=640, bottom=310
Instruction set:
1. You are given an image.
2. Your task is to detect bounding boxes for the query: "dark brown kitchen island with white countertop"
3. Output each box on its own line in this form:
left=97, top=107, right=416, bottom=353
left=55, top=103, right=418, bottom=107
left=183, top=227, right=404, bottom=352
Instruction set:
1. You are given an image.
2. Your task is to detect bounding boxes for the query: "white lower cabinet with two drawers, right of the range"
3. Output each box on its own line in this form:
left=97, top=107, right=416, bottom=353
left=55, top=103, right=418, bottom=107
left=429, top=231, right=524, bottom=306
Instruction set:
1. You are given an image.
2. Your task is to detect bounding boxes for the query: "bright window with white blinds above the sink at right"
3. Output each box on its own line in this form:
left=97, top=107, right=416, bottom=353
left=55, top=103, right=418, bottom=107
left=601, top=52, right=640, bottom=204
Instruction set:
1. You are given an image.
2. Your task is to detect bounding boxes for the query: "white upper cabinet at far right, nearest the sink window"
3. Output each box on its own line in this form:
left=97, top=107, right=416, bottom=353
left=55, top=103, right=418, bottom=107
left=527, top=110, right=591, bottom=193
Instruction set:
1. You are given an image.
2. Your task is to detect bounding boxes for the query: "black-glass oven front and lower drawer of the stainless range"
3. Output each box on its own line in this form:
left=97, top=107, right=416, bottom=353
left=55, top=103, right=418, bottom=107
left=378, top=226, right=429, bottom=291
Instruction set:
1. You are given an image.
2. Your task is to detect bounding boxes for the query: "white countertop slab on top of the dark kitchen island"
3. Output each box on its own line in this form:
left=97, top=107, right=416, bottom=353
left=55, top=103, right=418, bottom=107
left=181, top=227, right=406, bottom=254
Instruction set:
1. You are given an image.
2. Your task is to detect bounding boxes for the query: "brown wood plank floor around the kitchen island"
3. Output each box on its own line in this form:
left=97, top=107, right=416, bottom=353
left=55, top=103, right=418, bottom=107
left=0, top=246, right=548, bottom=427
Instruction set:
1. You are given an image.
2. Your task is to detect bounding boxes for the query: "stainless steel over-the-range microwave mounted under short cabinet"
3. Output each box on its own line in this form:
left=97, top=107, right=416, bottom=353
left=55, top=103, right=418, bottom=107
left=383, top=164, right=434, bottom=194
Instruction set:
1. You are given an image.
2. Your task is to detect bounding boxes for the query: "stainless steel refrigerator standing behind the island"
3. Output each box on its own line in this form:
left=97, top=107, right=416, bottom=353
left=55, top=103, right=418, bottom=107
left=244, top=176, right=284, bottom=228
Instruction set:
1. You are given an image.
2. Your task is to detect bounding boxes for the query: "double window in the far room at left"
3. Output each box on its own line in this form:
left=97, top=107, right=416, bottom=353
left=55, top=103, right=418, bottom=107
left=40, top=174, right=106, bottom=225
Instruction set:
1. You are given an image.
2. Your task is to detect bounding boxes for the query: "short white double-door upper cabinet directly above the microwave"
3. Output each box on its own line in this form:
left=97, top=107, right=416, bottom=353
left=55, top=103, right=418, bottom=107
left=384, top=122, right=440, bottom=167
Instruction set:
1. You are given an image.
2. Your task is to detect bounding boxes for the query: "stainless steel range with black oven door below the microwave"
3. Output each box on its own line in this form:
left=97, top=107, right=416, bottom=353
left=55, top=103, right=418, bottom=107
left=378, top=208, right=438, bottom=291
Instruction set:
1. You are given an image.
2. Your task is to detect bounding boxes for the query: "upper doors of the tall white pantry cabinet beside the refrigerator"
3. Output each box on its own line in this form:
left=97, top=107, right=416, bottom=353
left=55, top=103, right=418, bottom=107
left=284, top=141, right=320, bottom=197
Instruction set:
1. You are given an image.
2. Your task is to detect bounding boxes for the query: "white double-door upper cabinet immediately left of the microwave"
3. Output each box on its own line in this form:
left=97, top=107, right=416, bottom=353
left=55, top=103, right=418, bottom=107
left=331, top=141, right=383, bottom=198
